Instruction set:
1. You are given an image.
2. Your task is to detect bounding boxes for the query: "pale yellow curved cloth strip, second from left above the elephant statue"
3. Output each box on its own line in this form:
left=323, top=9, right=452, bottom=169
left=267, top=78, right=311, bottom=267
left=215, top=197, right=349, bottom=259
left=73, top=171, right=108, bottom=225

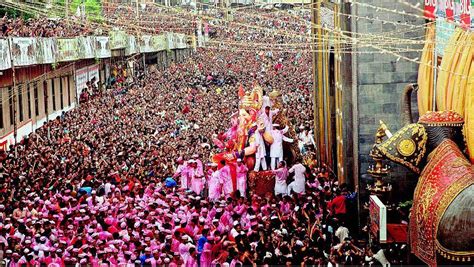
left=436, top=28, right=463, bottom=111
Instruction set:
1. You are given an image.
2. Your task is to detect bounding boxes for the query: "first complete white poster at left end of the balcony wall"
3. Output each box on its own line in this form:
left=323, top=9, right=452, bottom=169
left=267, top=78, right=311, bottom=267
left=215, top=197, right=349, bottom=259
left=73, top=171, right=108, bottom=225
left=10, top=37, right=38, bottom=66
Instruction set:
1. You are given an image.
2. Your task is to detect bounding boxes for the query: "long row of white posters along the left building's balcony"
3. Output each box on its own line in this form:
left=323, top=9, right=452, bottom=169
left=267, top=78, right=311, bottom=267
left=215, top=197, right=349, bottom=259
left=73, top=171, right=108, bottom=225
left=0, top=31, right=198, bottom=70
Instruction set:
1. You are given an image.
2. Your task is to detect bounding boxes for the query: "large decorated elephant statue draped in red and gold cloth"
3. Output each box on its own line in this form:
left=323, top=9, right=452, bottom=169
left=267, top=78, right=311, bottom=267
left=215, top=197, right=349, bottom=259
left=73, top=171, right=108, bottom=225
left=374, top=85, right=474, bottom=266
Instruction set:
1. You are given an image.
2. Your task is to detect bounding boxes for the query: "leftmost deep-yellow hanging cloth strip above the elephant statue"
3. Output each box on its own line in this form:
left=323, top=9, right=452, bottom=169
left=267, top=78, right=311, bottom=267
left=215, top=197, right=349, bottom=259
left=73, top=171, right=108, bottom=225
left=418, top=24, right=436, bottom=116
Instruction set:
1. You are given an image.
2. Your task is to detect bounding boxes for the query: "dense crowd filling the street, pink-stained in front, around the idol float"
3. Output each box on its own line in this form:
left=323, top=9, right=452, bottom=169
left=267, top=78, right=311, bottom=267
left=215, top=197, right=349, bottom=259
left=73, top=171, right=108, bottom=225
left=0, top=6, right=400, bottom=266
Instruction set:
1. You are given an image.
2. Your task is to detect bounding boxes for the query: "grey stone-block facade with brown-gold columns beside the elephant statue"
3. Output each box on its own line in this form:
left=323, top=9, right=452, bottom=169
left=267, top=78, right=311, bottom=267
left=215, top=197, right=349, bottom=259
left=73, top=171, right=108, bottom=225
left=314, top=0, right=425, bottom=199
